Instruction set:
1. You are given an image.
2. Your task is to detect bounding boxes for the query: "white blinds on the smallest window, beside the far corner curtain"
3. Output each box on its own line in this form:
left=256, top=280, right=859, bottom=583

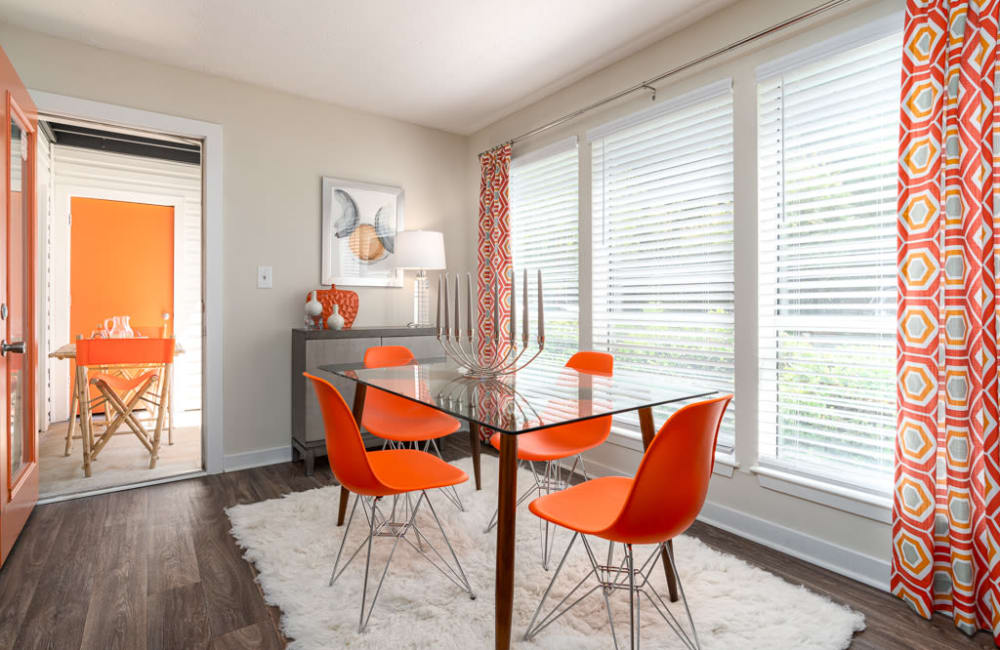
left=510, top=138, right=580, bottom=365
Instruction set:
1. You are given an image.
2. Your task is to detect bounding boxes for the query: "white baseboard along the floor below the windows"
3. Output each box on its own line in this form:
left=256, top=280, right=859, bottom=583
left=585, top=444, right=890, bottom=591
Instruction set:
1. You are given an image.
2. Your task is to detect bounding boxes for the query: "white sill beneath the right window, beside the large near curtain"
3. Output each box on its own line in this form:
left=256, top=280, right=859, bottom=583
left=750, top=465, right=892, bottom=524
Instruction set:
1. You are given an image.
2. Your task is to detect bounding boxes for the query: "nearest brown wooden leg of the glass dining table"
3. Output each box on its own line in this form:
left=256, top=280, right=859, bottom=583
left=495, top=434, right=517, bottom=650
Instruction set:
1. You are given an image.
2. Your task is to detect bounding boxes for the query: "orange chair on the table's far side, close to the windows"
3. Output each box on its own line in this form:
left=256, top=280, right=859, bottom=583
left=486, top=351, right=615, bottom=570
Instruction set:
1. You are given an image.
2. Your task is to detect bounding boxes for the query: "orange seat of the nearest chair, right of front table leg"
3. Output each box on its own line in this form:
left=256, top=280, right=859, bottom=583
left=528, top=476, right=633, bottom=542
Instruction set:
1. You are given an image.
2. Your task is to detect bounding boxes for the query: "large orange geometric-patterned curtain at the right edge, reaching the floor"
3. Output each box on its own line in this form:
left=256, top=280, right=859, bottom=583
left=891, top=0, right=1000, bottom=638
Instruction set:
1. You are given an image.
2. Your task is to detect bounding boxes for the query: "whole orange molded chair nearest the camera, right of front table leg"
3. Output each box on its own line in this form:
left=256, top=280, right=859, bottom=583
left=524, top=395, right=733, bottom=650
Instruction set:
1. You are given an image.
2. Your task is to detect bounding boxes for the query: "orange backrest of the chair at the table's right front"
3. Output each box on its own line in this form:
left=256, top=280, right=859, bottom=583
left=611, top=395, right=733, bottom=544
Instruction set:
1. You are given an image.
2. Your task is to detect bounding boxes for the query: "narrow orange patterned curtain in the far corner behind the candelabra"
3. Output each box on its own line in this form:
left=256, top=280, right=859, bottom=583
left=476, top=143, right=513, bottom=359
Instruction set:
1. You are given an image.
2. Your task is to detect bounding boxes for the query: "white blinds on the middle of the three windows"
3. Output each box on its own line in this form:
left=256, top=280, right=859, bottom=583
left=589, top=79, right=733, bottom=448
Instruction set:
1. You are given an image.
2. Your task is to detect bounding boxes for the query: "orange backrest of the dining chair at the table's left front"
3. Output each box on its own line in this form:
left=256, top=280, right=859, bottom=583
left=302, top=372, right=383, bottom=495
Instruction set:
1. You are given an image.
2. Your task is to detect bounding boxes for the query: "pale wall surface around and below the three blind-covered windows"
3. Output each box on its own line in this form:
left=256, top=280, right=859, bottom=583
left=465, top=0, right=904, bottom=587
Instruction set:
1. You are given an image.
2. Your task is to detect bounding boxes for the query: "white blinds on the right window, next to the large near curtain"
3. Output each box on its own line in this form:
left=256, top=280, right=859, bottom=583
left=757, top=23, right=902, bottom=492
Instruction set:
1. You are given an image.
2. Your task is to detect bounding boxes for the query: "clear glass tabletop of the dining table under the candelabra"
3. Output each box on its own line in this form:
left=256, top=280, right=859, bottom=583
left=319, top=357, right=718, bottom=434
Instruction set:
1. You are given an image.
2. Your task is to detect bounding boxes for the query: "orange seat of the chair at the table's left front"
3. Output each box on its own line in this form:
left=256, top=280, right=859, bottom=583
left=366, top=449, right=469, bottom=497
